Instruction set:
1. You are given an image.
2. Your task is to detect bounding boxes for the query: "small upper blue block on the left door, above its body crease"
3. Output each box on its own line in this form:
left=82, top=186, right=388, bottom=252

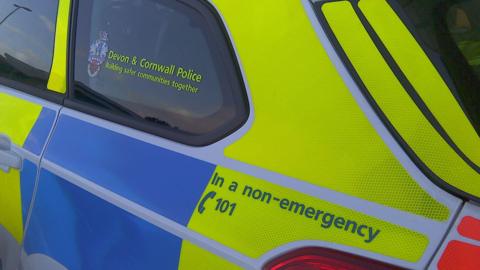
left=23, top=107, right=56, bottom=156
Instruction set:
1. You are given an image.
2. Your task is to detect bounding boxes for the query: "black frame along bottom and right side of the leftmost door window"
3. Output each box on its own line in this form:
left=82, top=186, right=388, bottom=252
left=0, top=0, right=65, bottom=105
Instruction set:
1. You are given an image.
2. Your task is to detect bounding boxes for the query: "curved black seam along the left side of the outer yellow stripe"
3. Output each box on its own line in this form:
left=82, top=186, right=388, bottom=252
left=313, top=0, right=480, bottom=202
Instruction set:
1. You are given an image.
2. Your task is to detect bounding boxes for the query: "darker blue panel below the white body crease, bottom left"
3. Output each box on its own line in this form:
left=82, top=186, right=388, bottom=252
left=25, top=170, right=181, bottom=270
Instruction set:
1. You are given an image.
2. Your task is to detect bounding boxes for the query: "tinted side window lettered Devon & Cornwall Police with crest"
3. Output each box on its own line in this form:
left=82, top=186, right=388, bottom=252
left=73, top=0, right=248, bottom=145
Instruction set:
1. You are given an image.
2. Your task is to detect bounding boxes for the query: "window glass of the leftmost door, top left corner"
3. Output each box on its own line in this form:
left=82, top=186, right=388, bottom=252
left=0, top=0, right=58, bottom=88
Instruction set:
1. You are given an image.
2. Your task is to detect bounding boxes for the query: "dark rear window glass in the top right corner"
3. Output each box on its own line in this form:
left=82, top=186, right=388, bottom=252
left=393, top=0, right=480, bottom=134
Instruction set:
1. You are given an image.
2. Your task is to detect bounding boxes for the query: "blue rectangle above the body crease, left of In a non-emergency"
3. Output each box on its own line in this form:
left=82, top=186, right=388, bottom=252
left=45, top=115, right=215, bottom=225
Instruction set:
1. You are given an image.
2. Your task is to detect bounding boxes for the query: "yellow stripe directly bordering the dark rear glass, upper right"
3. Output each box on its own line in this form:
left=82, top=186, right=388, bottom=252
left=359, top=0, right=480, bottom=169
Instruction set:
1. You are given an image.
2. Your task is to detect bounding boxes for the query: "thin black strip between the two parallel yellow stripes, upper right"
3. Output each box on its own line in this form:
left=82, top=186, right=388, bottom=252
left=344, top=2, right=480, bottom=173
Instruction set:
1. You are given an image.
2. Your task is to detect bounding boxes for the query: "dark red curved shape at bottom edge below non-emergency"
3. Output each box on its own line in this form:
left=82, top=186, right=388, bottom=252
left=264, top=247, right=402, bottom=270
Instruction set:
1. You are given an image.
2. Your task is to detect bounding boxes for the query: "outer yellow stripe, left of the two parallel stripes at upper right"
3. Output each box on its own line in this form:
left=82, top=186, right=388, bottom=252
left=322, top=1, right=480, bottom=196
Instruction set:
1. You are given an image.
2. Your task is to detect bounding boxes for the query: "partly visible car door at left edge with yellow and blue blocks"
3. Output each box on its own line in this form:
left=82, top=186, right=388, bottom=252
left=0, top=0, right=66, bottom=269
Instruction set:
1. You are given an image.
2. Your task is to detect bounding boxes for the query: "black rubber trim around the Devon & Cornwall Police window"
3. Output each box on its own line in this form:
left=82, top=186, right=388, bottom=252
left=64, top=0, right=250, bottom=147
